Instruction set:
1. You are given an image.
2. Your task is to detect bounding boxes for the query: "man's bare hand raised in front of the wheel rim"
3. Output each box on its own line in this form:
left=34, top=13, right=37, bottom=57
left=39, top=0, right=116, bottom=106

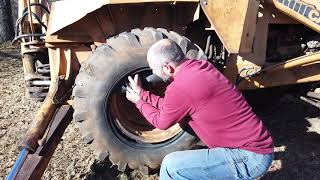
left=126, top=74, right=141, bottom=103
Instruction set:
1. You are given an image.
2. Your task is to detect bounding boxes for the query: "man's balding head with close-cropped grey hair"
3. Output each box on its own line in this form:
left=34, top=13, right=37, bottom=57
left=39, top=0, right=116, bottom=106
left=147, top=39, right=185, bottom=81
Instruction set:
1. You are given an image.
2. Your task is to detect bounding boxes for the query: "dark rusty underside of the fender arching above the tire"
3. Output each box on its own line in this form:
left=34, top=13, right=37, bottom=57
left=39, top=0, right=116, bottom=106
left=46, top=2, right=199, bottom=46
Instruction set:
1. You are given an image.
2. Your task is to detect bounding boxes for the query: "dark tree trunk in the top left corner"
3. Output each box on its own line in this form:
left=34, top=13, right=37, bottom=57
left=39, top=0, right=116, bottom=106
left=0, top=0, right=14, bottom=42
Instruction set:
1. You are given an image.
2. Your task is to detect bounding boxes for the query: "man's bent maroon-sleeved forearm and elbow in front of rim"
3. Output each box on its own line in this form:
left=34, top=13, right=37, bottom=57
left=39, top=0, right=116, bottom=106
left=136, top=87, right=192, bottom=130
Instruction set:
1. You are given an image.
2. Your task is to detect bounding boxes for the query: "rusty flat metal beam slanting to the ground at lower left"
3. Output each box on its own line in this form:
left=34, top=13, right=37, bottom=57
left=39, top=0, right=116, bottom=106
left=10, top=105, right=73, bottom=180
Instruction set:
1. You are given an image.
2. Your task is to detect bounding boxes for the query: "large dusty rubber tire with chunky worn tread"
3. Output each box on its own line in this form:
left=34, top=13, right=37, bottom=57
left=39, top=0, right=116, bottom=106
left=73, top=28, right=206, bottom=174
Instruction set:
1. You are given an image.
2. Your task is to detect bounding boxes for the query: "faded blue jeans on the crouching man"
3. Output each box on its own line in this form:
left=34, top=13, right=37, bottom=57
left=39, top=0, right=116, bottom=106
left=160, top=148, right=273, bottom=180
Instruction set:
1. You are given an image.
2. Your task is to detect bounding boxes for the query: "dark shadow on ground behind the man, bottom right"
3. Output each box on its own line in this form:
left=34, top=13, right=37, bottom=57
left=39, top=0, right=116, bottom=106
left=254, top=95, right=320, bottom=180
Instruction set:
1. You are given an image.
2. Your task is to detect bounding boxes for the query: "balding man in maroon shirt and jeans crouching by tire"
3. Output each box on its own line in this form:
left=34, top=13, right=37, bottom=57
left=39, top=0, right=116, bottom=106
left=126, top=39, right=273, bottom=180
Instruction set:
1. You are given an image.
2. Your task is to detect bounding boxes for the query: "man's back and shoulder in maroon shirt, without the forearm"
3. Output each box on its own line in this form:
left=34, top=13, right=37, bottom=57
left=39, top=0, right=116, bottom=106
left=170, top=60, right=273, bottom=154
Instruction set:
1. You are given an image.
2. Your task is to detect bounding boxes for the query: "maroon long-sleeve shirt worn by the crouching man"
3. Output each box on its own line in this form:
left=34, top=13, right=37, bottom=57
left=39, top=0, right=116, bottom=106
left=136, top=60, right=273, bottom=154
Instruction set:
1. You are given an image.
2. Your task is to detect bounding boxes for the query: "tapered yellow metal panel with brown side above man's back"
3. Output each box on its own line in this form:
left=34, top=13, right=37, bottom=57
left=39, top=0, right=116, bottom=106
left=200, top=0, right=260, bottom=53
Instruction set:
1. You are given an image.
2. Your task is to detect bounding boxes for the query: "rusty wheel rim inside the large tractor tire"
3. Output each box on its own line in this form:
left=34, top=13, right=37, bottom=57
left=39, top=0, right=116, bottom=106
left=107, top=68, right=182, bottom=144
